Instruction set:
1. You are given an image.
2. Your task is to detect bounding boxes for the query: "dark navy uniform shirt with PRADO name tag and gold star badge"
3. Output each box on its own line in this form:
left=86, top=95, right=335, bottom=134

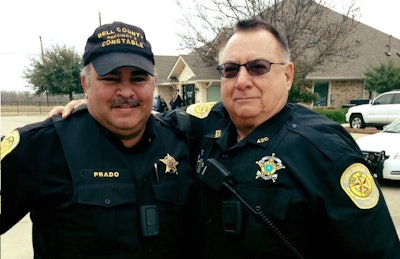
left=0, top=109, right=195, bottom=259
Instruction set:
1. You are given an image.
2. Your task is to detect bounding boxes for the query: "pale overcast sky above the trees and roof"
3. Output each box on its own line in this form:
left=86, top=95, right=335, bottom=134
left=0, top=0, right=400, bottom=91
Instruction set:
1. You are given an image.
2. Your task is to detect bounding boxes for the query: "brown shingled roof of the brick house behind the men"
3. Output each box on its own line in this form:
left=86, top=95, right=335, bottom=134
left=155, top=3, right=400, bottom=84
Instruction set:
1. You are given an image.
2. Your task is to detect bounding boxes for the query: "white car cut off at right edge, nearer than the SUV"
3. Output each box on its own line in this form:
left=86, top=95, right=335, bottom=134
left=356, top=117, right=400, bottom=180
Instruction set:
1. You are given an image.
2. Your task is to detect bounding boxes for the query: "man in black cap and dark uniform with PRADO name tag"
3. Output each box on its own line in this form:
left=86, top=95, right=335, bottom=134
left=0, top=22, right=197, bottom=259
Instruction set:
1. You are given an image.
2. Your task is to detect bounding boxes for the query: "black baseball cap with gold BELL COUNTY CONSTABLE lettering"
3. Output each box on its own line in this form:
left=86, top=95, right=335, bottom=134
left=83, top=22, right=154, bottom=76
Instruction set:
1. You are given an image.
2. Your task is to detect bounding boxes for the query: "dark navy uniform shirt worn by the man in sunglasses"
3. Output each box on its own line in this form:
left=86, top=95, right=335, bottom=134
left=162, top=103, right=400, bottom=259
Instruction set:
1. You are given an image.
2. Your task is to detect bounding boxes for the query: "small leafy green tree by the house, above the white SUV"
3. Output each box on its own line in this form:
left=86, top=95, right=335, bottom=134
left=364, top=61, right=400, bottom=93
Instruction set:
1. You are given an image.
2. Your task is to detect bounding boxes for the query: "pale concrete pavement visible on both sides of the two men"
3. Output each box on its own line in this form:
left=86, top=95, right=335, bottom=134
left=0, top=116, right=400, bottom=259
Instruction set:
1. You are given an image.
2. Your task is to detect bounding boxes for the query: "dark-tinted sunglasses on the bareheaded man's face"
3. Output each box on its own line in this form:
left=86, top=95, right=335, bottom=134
left=217, top=59, right=286, bottom=78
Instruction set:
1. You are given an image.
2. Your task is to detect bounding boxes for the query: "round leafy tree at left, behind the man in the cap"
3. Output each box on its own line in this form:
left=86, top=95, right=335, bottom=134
left=24, top=46, right=83, bottom=100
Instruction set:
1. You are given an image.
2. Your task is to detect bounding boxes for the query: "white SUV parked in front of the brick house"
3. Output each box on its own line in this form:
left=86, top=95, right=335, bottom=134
left=346, top=90, right=400, bottom=129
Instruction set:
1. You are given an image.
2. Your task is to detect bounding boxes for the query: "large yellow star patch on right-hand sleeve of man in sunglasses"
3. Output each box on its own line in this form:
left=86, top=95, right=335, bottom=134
left=340, top=163, right=379, bottom=209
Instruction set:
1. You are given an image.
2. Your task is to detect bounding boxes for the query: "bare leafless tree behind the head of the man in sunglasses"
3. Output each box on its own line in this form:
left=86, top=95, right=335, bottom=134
left=177, top=0, right=362, bottom=102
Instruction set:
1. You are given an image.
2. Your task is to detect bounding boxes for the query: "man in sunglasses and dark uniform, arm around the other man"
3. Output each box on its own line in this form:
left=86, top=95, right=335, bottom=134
left=44, top=19, right=400, bottom=259
